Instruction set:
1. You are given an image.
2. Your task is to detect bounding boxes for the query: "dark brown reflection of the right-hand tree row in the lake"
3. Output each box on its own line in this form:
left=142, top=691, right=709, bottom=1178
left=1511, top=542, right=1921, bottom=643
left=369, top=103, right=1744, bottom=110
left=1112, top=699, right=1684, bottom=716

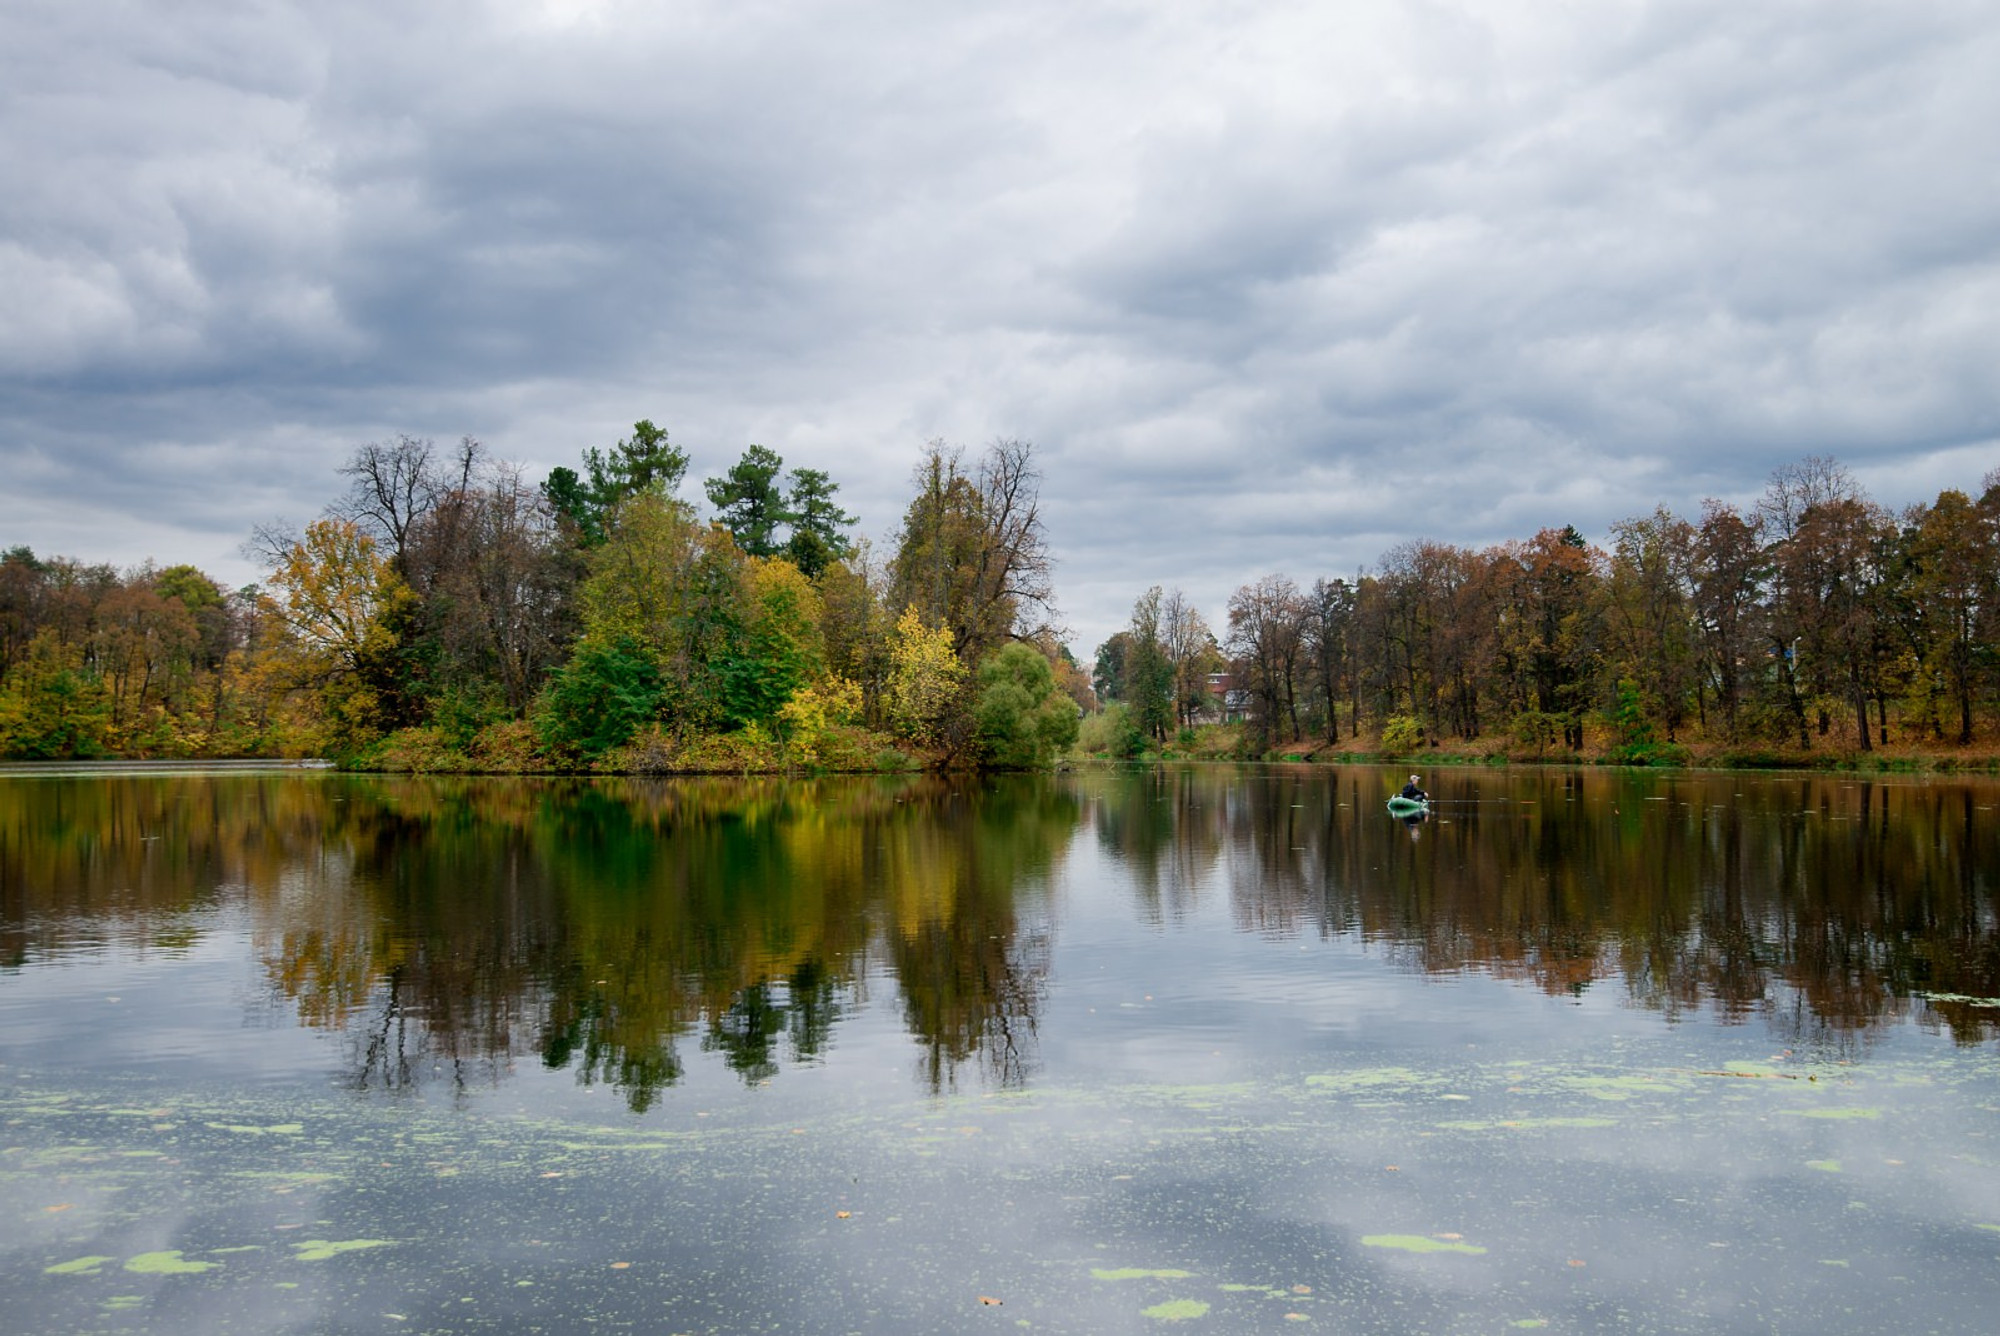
left=1200, top=770, right=2000, bottom=1046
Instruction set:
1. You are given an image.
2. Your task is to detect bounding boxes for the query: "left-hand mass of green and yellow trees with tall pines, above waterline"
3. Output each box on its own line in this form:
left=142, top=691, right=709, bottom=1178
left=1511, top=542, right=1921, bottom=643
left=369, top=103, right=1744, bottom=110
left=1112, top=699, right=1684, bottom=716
left=0, top=420, right=1088, bottom=770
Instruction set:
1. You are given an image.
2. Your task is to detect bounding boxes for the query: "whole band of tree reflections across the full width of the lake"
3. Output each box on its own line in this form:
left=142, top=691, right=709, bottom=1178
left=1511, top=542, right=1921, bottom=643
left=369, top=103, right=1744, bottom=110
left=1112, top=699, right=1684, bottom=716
left=0, top=768, right=2000, bottom=1108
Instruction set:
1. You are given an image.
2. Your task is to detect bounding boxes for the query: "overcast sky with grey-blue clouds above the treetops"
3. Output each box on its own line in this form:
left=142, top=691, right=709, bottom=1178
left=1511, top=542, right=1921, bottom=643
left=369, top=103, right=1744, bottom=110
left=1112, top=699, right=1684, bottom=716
left=0, top=0, right=2000, bottom=658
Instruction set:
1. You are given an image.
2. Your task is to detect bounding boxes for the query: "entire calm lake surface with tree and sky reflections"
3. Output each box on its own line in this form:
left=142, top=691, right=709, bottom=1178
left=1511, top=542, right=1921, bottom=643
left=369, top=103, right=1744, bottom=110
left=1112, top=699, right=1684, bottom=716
left=0, top=768, right=2000, bottom=1334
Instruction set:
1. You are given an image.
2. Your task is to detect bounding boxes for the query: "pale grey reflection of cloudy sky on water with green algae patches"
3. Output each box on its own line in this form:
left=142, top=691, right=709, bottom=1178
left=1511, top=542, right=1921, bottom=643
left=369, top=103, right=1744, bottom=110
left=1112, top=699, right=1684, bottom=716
left=0, top=768, right=2000, bottom=1332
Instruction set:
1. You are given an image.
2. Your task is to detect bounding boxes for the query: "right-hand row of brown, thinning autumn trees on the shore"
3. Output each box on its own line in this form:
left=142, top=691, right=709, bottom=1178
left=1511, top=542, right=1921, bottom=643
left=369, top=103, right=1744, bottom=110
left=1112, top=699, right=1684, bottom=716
left=1088, top=456, right=2000, bottom=762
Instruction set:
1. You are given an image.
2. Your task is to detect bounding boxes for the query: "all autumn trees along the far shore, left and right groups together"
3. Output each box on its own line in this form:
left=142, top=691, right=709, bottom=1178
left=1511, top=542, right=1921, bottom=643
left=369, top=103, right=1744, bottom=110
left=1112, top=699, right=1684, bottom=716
left=0, top=444, right=2000, bottom=770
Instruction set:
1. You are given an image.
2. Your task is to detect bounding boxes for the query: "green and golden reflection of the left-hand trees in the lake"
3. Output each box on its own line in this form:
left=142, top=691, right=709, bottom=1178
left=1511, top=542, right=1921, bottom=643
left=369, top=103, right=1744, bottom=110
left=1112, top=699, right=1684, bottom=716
left=15, top=776, right=1078, bottom=1108
